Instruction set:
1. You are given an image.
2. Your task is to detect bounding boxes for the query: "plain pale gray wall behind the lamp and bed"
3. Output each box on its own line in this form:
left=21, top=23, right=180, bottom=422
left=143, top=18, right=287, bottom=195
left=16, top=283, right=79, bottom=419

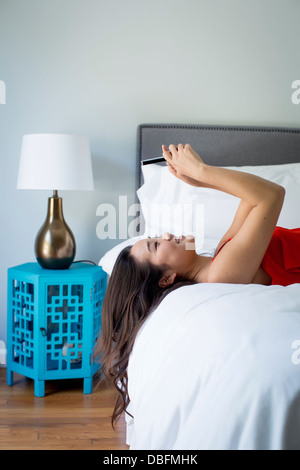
left=0, top=0, right=300, bottom=352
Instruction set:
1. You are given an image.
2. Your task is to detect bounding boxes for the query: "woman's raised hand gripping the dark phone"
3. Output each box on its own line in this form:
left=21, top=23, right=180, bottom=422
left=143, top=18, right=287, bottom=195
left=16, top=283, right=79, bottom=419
left=162, top=144, right=204, bottom=186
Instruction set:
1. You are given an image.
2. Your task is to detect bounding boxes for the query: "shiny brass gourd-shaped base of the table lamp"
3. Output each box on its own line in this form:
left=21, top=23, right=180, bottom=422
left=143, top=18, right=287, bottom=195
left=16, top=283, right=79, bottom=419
left=35, top=191, right=76, bottom=269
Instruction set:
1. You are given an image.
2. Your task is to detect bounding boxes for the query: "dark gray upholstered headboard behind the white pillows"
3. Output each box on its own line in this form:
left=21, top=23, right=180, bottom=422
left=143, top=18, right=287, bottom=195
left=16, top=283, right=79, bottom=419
left=136, top=124, right=300, bottom=188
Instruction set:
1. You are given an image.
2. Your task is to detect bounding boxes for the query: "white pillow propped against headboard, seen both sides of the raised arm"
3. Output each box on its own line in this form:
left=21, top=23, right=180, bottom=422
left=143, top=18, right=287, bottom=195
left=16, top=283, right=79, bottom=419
left=137, top=163, right=300, bottom=243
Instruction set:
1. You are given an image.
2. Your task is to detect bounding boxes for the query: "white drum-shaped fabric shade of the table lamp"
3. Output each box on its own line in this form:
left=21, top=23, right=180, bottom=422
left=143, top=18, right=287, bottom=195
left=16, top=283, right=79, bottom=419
left=17, top=134, right=94, bottom=190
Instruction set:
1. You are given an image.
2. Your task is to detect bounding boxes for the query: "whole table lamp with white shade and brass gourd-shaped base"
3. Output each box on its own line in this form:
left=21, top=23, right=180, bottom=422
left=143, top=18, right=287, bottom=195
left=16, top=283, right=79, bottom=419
left=17, top=134, right=94, bottom=269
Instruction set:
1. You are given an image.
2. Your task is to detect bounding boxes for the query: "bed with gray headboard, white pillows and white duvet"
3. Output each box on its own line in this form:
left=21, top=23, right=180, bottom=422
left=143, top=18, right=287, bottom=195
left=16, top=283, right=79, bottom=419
left=100, top=124, right=300, bottom=450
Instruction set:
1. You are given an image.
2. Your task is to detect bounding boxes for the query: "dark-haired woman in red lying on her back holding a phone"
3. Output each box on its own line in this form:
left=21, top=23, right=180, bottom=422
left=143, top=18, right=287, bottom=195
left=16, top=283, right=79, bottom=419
left=97, top=144, right=300, bottom=423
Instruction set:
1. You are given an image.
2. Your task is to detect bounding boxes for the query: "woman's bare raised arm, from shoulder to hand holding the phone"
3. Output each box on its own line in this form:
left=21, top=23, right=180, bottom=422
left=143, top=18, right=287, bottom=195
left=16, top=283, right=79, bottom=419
left=163, top=145, right=285, bottom=283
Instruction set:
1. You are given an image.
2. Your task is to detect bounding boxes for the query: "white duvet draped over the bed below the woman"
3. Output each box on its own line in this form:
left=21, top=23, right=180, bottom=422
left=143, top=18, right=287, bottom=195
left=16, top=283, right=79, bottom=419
left=126, top=284, right=300, bottom=450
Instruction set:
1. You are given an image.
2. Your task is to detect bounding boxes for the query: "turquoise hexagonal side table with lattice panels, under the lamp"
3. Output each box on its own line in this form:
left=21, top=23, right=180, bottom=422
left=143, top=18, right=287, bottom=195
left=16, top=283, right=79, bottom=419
left=7, top=263, right=107, bottom=396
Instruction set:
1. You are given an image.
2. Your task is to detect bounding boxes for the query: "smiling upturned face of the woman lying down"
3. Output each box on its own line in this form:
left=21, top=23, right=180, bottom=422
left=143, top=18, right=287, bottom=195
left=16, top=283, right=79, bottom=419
left=131, top=232, right=197, bottom=276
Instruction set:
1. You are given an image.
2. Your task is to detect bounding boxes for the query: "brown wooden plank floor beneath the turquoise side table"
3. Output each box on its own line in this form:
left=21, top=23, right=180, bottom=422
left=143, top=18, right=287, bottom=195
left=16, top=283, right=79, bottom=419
left=0, top=368, right=128, bottom=450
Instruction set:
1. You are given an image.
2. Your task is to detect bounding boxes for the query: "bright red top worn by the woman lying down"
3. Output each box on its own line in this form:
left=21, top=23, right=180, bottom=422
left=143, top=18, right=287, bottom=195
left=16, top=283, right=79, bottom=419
left=213, top=227, right=300, bottom=286
